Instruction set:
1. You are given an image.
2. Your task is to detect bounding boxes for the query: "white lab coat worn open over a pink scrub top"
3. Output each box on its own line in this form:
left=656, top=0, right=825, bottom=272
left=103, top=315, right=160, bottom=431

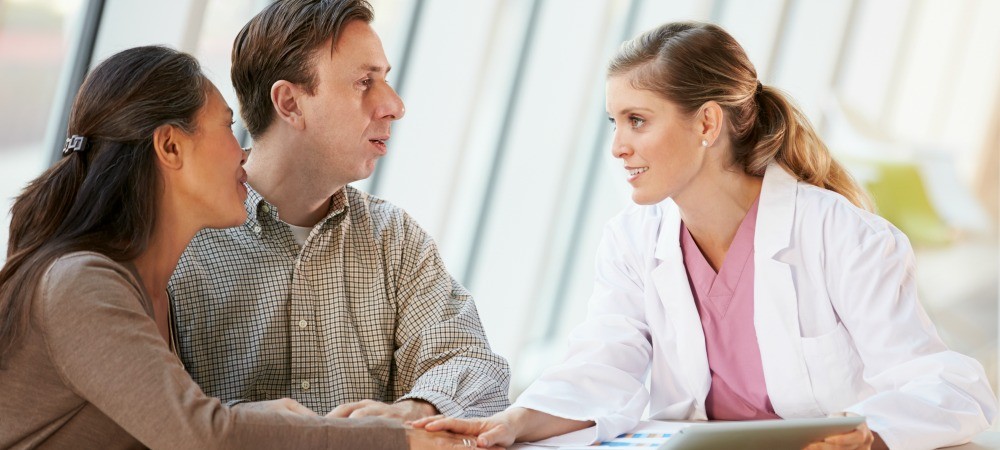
left=515, top=165, right=997, bottom=449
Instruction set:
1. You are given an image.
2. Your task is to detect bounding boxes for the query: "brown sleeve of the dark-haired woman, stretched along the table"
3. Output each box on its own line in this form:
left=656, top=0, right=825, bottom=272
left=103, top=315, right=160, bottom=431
left=34, top=255, right=407, bottom=449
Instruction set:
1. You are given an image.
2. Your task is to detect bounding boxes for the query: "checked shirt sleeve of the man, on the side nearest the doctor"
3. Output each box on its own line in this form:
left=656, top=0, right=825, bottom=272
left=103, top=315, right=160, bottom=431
left=393, top=214, right=510, bottom=417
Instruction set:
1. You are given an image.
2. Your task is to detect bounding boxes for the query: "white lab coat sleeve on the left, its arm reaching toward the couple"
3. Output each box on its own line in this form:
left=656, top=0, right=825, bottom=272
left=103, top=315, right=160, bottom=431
left=514, top=222, right=653, bottom=444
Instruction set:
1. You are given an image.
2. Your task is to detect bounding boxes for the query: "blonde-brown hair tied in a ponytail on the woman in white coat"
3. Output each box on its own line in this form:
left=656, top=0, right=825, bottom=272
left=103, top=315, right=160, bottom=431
left=608, top=22, right=871, bottom=210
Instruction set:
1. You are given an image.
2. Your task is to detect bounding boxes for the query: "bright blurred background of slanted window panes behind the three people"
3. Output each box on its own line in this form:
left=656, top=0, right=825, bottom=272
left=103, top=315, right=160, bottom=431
left=0, top=0, right=1000, bottom=395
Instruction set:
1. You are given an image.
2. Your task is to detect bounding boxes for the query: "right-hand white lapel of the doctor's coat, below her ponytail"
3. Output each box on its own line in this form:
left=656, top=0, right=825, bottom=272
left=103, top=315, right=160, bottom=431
left=754, top=164, right=823, bottom=418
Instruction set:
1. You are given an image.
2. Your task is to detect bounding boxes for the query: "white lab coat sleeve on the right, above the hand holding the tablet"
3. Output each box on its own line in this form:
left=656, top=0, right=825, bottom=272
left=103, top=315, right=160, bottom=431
left=829, top=229, right=997, bottom=448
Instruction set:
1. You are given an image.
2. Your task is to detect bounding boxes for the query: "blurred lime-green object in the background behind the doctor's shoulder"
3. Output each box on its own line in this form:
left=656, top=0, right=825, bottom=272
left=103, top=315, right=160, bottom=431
left=865, top=162, right=955, bottom=246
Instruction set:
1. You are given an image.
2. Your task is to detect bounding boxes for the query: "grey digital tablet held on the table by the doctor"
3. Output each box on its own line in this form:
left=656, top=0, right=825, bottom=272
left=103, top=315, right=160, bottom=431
left=660, top=416, right=865, bottom=450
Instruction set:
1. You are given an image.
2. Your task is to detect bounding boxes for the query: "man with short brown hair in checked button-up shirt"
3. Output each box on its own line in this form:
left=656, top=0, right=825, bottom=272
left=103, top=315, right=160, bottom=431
left=168, top=0, right=510, bottom=420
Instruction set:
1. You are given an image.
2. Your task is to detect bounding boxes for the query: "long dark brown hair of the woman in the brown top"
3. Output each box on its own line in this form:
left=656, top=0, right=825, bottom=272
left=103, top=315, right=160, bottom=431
left=0, top=46, right=209, bottom=368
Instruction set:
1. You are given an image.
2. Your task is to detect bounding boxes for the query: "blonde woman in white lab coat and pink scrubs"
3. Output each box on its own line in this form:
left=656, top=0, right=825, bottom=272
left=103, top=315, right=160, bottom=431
left=415, top=23, right=997, bottom=449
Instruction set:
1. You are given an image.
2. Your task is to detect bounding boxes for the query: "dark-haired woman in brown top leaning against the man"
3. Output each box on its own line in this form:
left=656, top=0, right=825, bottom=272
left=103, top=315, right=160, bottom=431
left=0, top=46, right=486, bottom=449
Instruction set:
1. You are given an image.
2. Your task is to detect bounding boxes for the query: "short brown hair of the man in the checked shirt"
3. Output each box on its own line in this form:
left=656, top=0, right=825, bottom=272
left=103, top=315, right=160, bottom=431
left=230, top=0, right=375, bottom=138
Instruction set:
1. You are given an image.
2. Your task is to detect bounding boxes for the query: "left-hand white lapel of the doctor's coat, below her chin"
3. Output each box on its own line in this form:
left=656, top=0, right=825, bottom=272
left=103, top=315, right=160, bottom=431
left=651, top=200, right=712, bottom=419
